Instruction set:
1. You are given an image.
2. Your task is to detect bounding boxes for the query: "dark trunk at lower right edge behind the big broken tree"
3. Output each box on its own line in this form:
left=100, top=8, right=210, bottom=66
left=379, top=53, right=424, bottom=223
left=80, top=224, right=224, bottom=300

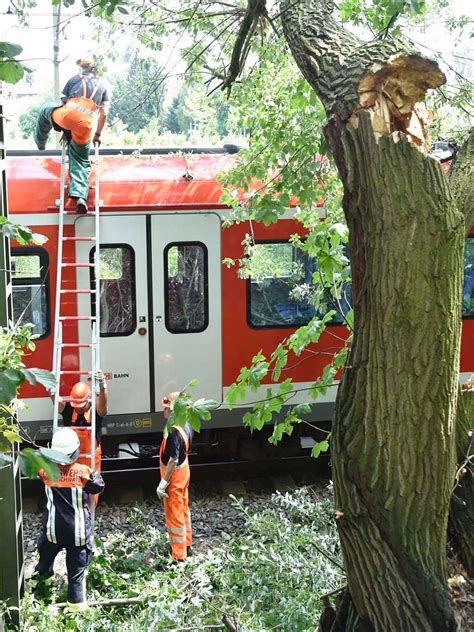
left=449, top=384, right=474, bottom=577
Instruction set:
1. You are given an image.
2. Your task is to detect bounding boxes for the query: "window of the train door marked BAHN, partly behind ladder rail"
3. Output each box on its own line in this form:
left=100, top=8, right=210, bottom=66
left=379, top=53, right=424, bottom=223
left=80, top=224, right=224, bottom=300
left=90, top=244, right=137, bottom=338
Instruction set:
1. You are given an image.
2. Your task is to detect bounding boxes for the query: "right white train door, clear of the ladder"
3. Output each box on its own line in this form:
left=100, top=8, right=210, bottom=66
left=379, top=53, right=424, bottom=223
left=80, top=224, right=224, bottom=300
left=150, top=212, right=222, bottom=409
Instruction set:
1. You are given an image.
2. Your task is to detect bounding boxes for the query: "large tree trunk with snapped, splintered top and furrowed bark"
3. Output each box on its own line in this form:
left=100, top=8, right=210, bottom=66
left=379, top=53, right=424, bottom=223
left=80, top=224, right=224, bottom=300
left=282, top=0, right=464, bottom=632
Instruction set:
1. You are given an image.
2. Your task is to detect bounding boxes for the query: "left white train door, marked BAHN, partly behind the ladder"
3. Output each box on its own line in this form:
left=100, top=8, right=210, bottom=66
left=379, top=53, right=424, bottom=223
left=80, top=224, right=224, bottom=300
left=76, top=214, right=151, bottom=415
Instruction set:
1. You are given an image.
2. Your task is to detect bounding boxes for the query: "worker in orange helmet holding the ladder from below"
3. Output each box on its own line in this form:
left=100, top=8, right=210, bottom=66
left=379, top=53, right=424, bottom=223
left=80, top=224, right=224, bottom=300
left=58, top=369, right=107, bottom=472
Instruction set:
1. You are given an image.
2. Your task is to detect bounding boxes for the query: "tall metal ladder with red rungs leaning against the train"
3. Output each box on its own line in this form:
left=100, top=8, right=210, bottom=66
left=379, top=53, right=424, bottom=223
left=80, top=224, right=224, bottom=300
left=53, top=144, right=100, bottom=492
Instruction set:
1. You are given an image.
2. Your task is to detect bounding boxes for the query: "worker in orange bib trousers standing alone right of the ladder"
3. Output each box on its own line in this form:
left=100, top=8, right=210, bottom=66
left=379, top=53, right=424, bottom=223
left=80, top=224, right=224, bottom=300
left=156, top=393, right=193, bottom=560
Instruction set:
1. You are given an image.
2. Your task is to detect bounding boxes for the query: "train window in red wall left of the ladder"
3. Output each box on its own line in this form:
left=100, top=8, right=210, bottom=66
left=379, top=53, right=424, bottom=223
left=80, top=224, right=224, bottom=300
left=11, top=247, right=49, bottom=338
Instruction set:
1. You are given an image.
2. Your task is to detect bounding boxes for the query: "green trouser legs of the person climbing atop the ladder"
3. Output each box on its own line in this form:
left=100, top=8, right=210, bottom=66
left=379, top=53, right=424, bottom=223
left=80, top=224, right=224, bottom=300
left=33, top=103, right=91, bottom=200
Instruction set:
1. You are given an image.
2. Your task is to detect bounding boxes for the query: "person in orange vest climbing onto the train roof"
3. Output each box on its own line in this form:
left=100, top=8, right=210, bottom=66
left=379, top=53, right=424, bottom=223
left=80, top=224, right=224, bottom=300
left=33, top=58, right=109, bottom=213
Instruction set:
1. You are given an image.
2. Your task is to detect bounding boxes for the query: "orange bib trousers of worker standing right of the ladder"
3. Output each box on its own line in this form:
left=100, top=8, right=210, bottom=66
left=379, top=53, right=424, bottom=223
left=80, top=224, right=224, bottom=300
left=160, top=460, right=193, bottom=560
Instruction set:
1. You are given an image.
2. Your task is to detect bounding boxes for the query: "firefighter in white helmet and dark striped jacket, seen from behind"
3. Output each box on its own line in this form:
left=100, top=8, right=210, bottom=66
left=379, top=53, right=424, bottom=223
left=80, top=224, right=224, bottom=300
left=31, top=428, right=105, bottom=612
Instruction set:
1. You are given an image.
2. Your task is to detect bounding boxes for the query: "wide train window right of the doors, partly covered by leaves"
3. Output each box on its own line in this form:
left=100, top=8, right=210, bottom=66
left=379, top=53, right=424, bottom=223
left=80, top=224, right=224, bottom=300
left=247, top=242, right=351, bottom=329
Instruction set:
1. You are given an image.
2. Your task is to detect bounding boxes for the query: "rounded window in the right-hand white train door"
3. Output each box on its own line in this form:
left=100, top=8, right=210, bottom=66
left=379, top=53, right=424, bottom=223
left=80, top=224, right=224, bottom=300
left=164, top=242, right=209, bottom=334
